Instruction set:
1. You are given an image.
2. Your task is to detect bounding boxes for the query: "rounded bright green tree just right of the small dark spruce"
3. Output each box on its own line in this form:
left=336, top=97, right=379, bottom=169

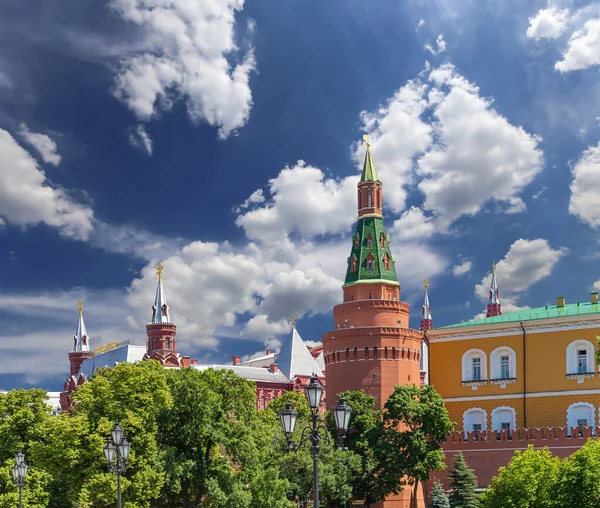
left=481, top=445, right=556, bottom=508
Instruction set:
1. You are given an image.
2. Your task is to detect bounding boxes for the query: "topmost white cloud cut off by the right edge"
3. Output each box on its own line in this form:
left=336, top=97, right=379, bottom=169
left=554, top=19, right=600, bottom=72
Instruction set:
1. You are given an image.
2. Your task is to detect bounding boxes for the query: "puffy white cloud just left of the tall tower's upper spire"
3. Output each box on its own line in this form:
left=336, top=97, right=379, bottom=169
left=236, top=161, right=358, bottom=243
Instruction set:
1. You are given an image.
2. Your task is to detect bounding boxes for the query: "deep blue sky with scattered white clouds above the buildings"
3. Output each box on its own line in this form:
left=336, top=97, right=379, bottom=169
left=0, top=0, right=600, bottom=390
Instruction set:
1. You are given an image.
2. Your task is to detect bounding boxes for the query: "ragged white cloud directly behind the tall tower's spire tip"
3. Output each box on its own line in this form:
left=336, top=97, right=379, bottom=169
left=353, top=80, right=432, bottom=212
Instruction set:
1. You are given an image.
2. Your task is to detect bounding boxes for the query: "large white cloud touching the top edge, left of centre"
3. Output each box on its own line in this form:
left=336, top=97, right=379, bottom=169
left=111, top=0, right=256, bottom=139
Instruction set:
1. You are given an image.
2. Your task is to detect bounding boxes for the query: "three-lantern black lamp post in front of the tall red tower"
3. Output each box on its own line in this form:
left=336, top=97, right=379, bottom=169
left=279, top=376, right=352, bottom=508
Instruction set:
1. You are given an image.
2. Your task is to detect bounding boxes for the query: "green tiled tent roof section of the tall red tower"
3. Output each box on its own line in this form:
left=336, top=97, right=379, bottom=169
left=344, top=217, right=398, bottom=286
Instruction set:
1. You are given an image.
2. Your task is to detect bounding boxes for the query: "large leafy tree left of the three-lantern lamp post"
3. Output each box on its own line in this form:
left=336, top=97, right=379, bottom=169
left=159, top=369, right=288, bottom=508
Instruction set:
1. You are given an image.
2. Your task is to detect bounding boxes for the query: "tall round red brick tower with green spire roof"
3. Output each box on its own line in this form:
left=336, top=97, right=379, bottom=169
left=323, top=138, right=421, bottom=408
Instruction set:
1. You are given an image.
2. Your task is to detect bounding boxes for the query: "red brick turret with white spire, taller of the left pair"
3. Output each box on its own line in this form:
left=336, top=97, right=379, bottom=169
left=145, top=264, right=190, bottom=368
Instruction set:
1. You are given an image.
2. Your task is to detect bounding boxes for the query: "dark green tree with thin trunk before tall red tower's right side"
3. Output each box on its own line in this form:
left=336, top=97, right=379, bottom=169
left=373, top=385, right=453, bottom=508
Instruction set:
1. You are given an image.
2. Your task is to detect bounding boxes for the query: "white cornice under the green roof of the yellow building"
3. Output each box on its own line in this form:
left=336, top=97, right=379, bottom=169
left=427, top=316, right=600, bottom=342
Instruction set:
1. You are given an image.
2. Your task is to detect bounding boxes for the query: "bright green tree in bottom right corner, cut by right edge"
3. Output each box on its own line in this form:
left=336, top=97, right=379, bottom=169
left=555, top=439, right=600, bottom=507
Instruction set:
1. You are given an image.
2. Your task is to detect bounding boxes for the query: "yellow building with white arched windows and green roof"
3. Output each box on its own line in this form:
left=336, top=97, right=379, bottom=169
left=425, top=290, right=600, bottom=431
